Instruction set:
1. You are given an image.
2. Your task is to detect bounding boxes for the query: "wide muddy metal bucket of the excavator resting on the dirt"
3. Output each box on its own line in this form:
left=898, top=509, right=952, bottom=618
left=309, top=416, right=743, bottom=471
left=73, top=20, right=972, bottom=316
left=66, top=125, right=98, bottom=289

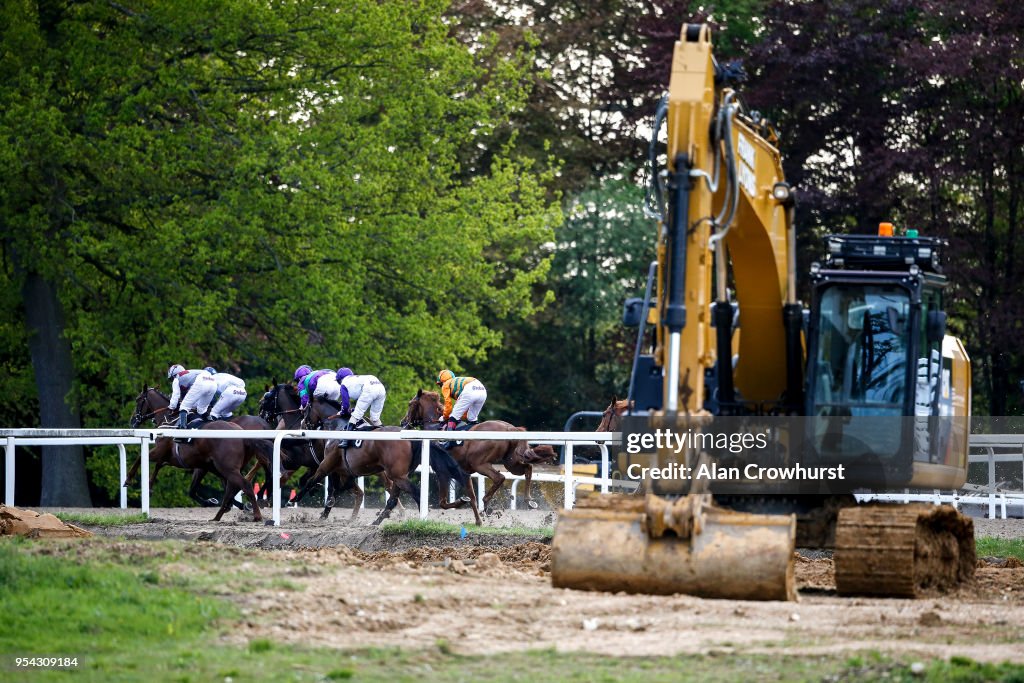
left=551, top=495, right=797, bottom=600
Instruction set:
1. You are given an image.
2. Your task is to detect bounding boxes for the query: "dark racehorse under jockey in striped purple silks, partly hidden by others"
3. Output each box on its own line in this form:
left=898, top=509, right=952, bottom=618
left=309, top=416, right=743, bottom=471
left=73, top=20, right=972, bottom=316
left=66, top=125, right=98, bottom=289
left=246, top=383, right=344, bottom=507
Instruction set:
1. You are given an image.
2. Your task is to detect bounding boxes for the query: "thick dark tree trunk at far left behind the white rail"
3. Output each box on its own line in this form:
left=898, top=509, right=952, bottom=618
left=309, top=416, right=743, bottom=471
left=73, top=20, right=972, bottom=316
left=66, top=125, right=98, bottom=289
left=22, top=271, right=92, bottom=507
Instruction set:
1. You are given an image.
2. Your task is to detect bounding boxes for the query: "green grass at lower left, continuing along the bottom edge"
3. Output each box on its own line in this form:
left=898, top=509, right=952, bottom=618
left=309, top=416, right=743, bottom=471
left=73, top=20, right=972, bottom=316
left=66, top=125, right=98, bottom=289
left=0, top=539, right=1024, bottom=683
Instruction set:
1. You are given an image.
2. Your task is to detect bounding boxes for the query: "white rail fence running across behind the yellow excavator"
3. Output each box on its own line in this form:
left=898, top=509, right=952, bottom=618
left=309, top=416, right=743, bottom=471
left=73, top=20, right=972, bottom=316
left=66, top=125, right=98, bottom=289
left=0, top=429, right=1024, bottom=525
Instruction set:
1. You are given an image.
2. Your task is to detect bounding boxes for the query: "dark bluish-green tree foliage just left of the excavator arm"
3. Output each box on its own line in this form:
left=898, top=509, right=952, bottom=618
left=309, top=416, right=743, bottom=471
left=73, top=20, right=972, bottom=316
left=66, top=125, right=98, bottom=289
left=480, top=167, right=657, bottom=429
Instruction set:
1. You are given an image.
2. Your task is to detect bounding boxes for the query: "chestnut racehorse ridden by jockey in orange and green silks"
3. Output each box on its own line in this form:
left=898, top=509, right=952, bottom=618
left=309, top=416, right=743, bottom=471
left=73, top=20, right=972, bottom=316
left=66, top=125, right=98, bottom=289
left=401, top=389, right=558, bottom=526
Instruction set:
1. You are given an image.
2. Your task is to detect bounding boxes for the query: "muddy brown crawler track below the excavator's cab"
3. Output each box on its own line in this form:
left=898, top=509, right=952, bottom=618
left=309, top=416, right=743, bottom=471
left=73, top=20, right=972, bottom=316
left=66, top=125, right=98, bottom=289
left=833, top=504, right=975, bottom=598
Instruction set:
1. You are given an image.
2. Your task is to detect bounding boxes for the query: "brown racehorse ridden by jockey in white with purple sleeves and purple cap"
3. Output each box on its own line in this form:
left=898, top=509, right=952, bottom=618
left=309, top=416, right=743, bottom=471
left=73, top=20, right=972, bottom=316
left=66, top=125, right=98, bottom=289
left=299, top=396, right=425, bottom=526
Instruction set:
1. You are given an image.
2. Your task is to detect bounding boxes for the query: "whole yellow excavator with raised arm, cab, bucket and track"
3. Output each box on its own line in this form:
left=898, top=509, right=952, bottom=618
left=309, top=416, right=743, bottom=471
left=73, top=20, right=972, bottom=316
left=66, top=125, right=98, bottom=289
left=551, top=25, right=975, bottom=600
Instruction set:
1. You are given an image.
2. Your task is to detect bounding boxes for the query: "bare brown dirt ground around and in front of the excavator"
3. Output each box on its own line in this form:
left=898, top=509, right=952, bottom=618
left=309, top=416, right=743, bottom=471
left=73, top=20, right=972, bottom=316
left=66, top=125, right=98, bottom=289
left=39, top=508, right=1024, bottom=663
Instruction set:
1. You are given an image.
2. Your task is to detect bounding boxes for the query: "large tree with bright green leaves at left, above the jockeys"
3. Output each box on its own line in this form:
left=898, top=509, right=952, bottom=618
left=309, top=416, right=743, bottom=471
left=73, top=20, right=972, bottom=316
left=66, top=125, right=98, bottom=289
left=0, top=0, right=559, bottom=504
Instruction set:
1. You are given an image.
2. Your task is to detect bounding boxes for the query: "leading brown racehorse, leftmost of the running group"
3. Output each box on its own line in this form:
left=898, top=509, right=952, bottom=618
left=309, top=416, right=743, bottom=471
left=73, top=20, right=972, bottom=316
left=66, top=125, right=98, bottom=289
left=125, top=388, right=263, bottom=522
